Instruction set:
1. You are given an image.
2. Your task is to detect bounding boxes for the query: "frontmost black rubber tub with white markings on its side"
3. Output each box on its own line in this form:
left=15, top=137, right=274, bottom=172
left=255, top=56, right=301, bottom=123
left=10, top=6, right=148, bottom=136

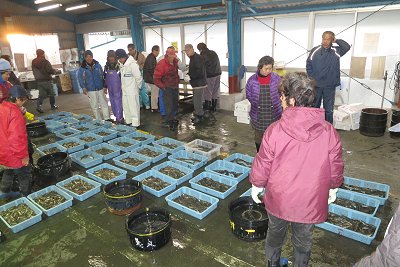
left=125, top=208, right=171, bottom=251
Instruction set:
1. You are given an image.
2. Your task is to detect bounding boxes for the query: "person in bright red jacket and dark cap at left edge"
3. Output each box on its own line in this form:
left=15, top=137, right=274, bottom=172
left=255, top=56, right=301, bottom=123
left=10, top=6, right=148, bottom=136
left=0, top=85, right=31, bottom=199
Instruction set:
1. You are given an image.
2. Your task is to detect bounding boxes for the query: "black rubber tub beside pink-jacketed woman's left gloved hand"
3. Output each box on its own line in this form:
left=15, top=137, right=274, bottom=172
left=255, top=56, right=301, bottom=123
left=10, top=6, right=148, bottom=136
left=229, top=197, right=268, bottom=241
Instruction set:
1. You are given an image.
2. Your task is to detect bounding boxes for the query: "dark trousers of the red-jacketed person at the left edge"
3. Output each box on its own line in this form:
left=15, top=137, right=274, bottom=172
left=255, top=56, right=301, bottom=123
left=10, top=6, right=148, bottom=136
left=0, top=165, right=32, bottom=196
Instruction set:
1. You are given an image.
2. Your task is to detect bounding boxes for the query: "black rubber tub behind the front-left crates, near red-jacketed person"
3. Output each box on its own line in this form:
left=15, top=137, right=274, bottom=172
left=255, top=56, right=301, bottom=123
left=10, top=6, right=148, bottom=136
left=36, top=152, right=71, bottom=178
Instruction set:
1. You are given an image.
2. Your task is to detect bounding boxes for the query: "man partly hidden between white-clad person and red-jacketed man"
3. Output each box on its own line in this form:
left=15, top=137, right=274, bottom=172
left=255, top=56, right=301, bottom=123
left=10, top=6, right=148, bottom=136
left=143, top=45, right=160, bottom=112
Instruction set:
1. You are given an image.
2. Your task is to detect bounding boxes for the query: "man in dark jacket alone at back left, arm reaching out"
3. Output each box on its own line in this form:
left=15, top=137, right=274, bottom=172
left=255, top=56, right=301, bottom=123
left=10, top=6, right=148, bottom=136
left=32, top=49, right=61, bottom=113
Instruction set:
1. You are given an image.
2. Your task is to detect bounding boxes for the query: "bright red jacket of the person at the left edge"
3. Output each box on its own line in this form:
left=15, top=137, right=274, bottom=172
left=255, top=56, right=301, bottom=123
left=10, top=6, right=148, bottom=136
left=0, top=101, right=29, bottom=168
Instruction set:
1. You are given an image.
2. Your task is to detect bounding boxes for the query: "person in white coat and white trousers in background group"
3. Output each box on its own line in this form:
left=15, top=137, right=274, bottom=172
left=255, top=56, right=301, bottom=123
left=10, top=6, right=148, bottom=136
left=115, top=49, right=142, bottom=127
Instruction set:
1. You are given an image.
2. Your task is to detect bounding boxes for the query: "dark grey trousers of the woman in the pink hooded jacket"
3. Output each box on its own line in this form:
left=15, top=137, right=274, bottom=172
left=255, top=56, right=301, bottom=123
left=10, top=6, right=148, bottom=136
left=265, top=214, right=314, bottom=267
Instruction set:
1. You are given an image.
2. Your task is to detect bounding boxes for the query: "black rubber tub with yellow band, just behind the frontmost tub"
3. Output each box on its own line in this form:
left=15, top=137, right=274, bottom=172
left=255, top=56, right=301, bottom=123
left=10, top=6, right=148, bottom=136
left=103, top=179, right=143, bottom=215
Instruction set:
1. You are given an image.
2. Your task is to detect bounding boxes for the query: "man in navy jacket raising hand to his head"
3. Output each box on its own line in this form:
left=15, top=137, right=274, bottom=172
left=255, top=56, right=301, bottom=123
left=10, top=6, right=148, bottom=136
left=306, top=31, right=350, bottom=123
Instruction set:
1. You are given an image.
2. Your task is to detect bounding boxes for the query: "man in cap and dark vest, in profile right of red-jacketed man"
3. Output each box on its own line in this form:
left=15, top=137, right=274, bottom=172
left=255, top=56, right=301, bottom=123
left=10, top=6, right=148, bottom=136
left=185, top=44, right=207, bottom=124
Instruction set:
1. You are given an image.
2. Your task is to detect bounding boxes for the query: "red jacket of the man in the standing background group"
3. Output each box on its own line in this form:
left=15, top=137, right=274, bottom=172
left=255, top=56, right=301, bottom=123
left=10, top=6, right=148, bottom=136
left=153, top=58, right=179, bottom=89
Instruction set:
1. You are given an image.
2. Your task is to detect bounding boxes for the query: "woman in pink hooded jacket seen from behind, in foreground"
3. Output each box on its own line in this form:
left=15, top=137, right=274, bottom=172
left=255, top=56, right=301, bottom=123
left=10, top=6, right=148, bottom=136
left=250, top=73, right=343, bottom=267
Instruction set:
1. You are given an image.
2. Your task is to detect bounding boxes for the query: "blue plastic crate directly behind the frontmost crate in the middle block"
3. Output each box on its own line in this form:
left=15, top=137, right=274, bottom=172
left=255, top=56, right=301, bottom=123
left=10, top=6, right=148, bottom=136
left=189, top=172, right=238, bottom=199
